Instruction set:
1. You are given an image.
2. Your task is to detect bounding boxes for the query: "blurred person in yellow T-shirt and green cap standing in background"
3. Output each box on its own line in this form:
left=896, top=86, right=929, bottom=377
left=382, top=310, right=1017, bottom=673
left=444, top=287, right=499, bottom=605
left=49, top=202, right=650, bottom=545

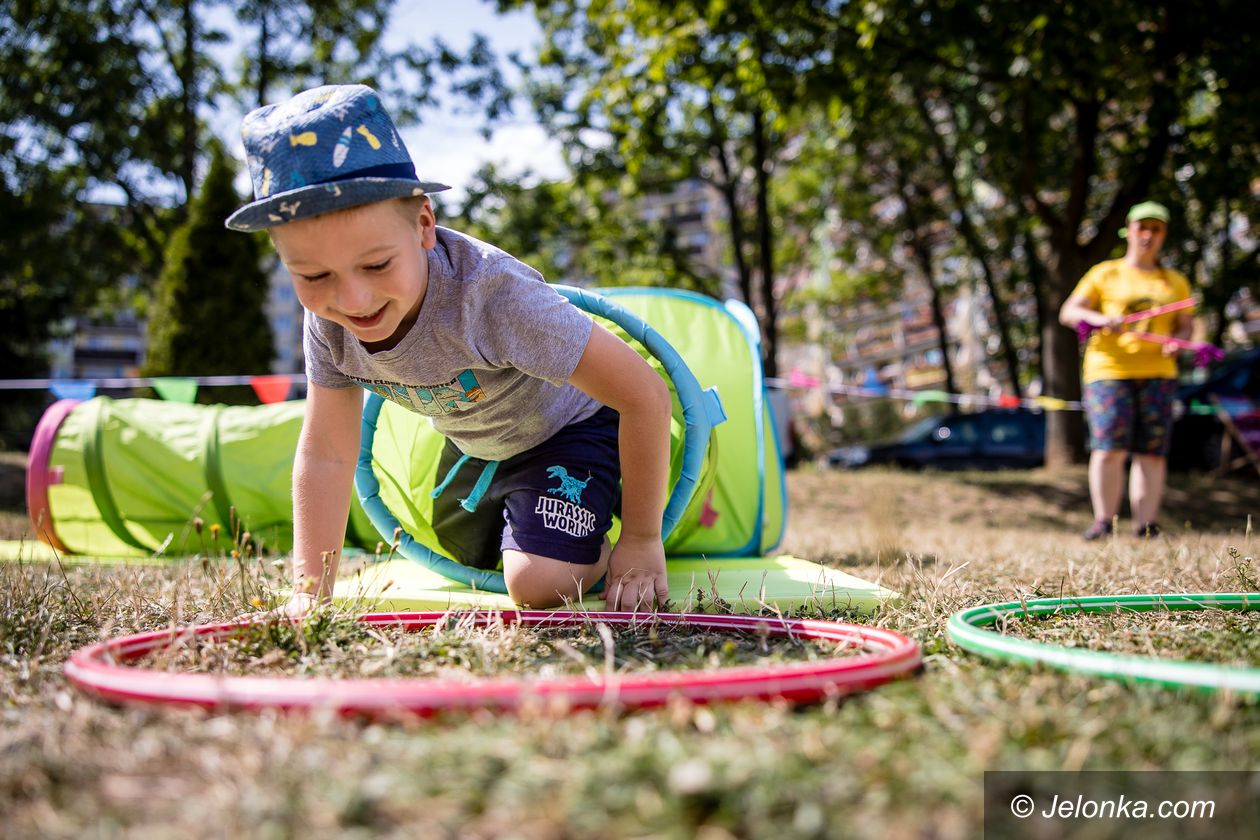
left=1058, top=201, right=1193, bottom=540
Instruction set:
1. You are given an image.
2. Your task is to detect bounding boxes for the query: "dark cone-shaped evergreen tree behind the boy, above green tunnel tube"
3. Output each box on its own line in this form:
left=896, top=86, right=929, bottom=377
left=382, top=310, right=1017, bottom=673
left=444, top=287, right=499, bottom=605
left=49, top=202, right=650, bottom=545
left=145, top=144, right=272, bottom=402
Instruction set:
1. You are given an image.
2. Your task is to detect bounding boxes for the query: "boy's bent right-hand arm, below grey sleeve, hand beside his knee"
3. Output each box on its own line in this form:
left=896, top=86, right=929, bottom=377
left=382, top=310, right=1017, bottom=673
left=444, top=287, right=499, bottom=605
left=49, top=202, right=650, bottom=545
left=570, top=324, right=670, bottom=610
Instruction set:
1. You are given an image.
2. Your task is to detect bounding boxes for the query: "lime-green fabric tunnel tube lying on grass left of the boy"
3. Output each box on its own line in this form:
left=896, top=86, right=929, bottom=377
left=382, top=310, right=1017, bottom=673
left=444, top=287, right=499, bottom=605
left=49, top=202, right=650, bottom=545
left=26, top=397, right=378, bottom=557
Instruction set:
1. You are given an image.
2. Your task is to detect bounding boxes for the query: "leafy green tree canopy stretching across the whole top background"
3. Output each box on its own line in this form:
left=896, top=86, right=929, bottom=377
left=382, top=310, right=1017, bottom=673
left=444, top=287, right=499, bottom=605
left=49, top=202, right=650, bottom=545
left=0, top=0, right=1260, bottom=462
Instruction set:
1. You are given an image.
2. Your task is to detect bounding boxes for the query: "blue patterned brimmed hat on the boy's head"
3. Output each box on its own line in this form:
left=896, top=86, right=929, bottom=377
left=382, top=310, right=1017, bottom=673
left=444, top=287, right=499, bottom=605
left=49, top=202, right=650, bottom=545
left=227, top=84, right=450, bottom=232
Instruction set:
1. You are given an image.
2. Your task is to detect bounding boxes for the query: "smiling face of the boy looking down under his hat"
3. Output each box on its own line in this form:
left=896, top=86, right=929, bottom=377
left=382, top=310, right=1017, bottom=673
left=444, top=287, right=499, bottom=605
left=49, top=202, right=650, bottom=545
left=271, top=200, right=437, bottom=353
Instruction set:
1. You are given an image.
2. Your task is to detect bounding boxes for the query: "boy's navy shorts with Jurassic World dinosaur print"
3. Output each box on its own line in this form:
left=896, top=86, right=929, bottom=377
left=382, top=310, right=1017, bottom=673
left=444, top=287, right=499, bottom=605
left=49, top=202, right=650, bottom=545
left=433, top=406, right=621, bottom=569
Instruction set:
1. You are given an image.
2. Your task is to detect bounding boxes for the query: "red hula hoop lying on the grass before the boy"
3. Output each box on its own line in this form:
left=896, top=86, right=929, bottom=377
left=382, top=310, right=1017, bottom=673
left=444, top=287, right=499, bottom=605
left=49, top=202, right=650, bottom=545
left=66, top=610, right=922, bottom=717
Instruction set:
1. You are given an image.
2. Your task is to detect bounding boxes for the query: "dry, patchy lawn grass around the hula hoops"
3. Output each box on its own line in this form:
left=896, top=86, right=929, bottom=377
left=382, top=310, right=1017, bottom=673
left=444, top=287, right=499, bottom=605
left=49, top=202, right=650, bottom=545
left=0, top=470, right=1260, bottom=840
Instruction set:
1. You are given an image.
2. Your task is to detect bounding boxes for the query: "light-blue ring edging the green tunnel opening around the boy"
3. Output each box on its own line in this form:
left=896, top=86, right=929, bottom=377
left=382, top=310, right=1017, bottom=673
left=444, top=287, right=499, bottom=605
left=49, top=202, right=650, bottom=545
left=354, top=286, right=726, bottom=594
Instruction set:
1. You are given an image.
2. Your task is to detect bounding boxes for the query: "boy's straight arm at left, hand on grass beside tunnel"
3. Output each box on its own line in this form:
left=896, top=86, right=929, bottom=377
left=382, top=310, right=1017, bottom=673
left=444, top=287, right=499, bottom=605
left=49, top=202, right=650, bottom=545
left=285, top=383, right=363, bottom=616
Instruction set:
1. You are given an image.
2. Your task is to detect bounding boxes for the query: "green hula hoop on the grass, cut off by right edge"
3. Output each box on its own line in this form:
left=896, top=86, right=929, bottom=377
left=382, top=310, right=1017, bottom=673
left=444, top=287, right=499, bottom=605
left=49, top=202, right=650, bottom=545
left=946, top=592, right=1260, bottom=696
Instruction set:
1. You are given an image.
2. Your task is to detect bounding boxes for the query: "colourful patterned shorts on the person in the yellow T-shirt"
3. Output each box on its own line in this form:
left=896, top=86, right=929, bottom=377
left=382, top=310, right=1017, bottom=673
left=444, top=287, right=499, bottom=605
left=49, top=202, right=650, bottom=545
left=1085, top=379, right=1177, bottom=456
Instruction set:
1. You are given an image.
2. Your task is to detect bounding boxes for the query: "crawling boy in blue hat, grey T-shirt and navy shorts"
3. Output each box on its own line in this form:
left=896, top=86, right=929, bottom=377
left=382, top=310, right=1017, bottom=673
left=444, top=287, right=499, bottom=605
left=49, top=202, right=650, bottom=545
left=227, top=84, right=670, bottom=616
